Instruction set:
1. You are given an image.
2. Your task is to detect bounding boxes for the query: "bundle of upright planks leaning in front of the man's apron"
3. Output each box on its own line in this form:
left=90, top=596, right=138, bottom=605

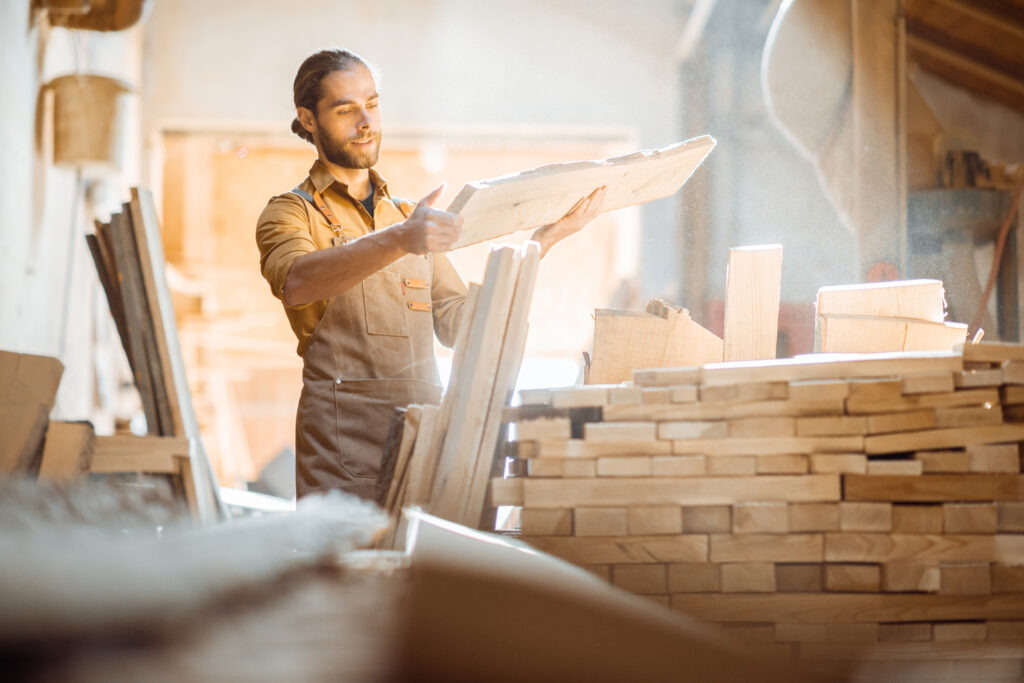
left=379, top=242, right=541, bottom=527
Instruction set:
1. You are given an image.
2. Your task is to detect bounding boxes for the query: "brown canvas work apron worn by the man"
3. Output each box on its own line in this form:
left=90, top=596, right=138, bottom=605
left=295, top=189, right=441, bottom=499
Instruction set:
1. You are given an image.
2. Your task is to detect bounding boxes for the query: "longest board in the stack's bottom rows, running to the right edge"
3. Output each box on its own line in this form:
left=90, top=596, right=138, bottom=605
left=672, top=593, right=1024, bottom=624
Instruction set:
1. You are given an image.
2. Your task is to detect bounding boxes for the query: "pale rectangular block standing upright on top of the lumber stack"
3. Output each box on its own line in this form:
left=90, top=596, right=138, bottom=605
left=723, top=245, right=782, bottom=361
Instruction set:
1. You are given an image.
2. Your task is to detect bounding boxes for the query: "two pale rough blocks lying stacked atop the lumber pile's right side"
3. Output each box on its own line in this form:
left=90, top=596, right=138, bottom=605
left=815, top=280, right=967, bottom=353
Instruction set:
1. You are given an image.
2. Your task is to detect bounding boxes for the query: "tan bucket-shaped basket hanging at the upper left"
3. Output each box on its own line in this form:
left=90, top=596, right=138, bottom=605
left=44, top=74, right=132, bottom=175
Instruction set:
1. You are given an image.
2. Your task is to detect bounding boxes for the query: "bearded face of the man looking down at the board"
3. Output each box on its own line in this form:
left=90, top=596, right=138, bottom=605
left=314, top=63, right=381, bottom=168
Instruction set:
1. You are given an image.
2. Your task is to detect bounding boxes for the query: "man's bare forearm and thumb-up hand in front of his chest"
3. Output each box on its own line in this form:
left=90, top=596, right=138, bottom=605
left=284, top=184, right=462, bottom=306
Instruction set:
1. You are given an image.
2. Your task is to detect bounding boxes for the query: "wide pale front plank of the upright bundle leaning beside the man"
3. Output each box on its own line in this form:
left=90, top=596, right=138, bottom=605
left=430, top=247, right=520, bottom=518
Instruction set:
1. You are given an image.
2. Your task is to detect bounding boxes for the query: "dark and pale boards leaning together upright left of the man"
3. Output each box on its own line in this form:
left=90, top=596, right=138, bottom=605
left=86, top=187, right=222, bottom=523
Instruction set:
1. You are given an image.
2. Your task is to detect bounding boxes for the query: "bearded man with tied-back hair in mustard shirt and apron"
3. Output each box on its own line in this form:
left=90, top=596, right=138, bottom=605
left=256, top=50, right=604, bottom=498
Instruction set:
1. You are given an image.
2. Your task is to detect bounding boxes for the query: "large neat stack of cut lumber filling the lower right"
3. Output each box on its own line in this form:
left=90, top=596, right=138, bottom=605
left=493, top=344, right=1024, bottom=679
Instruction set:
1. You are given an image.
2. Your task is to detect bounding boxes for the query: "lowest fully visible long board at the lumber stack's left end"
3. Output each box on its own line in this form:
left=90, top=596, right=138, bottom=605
left=529, top=533, right=708, bottom=564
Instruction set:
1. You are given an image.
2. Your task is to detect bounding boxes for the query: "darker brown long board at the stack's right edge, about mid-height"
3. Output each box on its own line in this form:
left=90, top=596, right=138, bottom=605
left=843, top=475, right=1024, bottom=503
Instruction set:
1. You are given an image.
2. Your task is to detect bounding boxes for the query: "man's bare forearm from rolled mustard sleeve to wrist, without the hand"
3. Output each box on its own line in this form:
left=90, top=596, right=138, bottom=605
left=284, top=228, right=407, bottom=306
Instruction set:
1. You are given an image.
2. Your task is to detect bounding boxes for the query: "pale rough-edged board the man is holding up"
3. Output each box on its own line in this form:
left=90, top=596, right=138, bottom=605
left=447, top=135, right=715, bottom=249
